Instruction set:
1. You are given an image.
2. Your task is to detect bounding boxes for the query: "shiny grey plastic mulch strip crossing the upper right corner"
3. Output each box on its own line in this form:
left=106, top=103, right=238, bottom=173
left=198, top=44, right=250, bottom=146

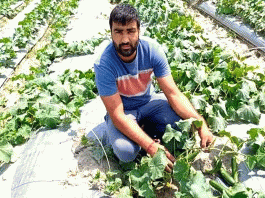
left=193, top=2, right=265, bottom=52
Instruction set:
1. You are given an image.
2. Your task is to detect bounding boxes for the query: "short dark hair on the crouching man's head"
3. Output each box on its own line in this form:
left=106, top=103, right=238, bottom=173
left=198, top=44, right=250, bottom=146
left=109, top=4, right=140, bottom=29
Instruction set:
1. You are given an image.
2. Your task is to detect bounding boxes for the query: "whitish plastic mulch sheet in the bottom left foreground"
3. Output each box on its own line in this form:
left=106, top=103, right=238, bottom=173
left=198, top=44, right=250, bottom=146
left=11, top=130, right=107, bottom=198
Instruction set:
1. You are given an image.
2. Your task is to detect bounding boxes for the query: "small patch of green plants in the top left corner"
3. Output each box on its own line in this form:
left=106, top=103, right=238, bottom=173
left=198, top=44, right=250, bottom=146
left=0, top=0, right=30, bottom=19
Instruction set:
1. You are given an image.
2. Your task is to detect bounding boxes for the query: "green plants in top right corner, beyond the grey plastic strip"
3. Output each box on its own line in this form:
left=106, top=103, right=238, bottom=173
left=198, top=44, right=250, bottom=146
left=215, top=0, right=265, bottom=35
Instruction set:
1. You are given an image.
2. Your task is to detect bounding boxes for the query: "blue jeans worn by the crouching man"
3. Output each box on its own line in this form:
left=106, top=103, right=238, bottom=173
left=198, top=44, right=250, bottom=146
left=105, top=94, right=181, bottom=162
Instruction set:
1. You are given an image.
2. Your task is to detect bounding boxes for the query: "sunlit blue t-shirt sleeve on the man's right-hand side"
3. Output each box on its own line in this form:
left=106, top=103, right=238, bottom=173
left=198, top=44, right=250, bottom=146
left=150, top=39, right=171, bottom=78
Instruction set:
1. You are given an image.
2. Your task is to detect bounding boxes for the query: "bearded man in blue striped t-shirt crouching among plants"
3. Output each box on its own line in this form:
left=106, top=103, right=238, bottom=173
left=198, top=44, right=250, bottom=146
left=95, top=4, right=212, bottom=171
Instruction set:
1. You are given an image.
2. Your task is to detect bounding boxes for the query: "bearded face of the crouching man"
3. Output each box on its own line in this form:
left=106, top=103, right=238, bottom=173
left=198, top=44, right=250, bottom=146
left=111, top=21, right=140, bottom=62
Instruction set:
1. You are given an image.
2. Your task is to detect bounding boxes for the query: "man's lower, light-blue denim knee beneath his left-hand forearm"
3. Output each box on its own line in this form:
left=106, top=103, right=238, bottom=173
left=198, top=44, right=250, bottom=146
left=112, top=139, right=140, bottom=162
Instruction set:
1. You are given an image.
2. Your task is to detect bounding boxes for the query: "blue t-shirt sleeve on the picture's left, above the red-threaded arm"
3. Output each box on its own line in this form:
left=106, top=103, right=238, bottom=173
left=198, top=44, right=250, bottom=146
left=94, top=59, right=118, bottom=96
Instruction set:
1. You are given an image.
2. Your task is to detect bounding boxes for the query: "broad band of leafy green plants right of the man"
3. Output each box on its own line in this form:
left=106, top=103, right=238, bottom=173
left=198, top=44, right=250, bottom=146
left=139, top=1, right=265, bottom=132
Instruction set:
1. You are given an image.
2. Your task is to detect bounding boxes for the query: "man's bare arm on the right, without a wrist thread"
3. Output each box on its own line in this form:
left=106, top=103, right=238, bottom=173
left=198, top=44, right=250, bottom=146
left=157, top=75, right=213, bottom=148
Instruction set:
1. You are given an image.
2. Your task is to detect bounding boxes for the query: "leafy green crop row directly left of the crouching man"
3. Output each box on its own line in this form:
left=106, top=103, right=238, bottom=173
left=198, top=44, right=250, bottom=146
left=0, top=0, right=104, bottom=163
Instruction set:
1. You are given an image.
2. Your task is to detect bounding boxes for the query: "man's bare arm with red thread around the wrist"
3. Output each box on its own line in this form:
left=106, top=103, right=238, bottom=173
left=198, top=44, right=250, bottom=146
left=101, top=93, right=175, bottom=172
